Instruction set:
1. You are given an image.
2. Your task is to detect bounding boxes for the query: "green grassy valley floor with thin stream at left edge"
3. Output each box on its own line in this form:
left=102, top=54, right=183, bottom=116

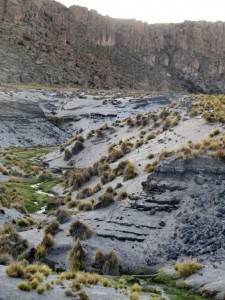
left=0, top=147, right=60, bottom=212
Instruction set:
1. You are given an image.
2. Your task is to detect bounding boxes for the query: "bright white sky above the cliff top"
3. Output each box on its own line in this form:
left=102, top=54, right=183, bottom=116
left=56, top=0, right=225, bottom=24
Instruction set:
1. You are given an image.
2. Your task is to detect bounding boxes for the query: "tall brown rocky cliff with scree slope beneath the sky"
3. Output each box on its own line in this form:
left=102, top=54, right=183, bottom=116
left=0, top=0, right=225, bottom=92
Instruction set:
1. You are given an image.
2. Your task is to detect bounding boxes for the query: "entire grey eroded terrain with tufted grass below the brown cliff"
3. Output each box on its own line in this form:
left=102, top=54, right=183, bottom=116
left=0, top=87, right=225, bottom=300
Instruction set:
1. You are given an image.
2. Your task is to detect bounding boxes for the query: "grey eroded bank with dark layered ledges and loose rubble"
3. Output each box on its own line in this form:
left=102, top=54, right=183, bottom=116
left=48, top=157, right=225, bottom=272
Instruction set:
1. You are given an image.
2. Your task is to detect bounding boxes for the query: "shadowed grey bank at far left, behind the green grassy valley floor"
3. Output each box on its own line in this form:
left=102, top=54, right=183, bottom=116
left=0, top=93, right=69, bottom=147
